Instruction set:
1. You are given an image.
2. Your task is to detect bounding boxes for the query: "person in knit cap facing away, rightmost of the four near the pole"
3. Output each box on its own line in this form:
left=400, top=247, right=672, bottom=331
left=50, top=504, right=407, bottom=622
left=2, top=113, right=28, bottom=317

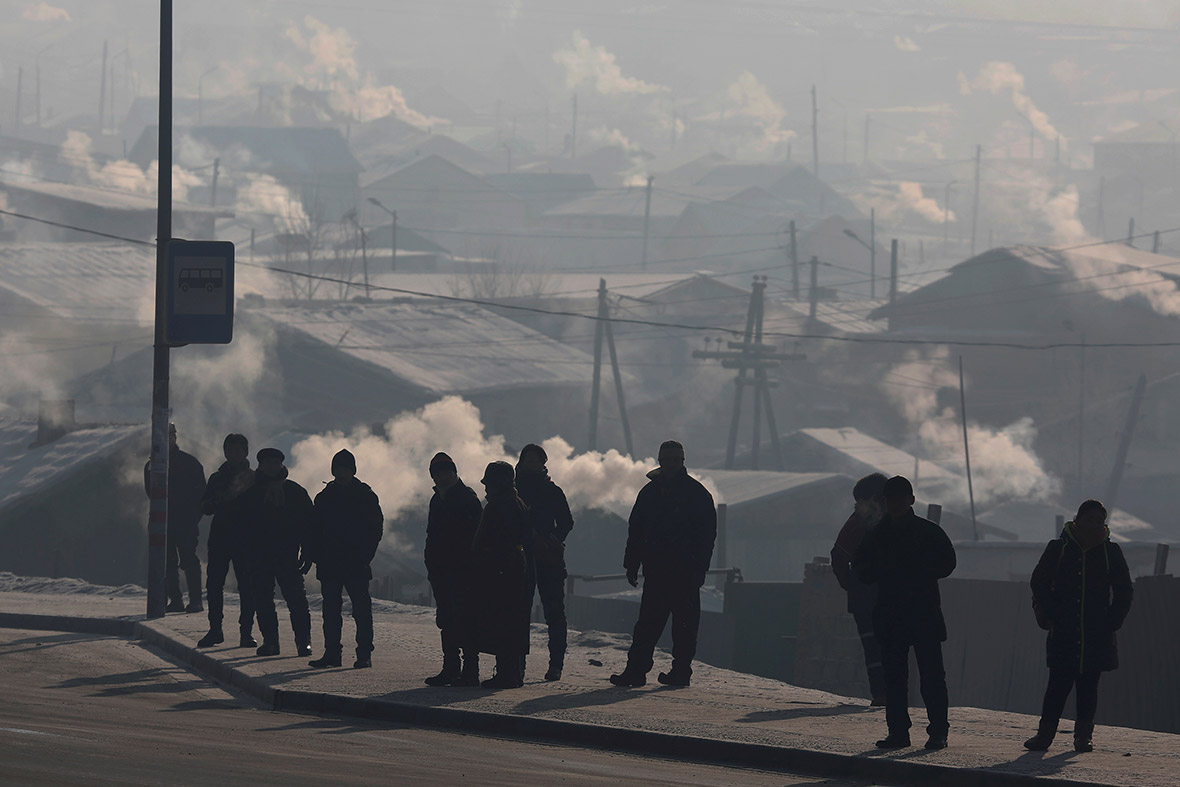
left=308, top=448, right=385, bottom=669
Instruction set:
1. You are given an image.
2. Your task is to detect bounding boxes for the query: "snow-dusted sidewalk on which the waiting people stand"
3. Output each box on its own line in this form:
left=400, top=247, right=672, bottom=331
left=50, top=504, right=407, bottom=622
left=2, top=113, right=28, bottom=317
left=0, top=585, right=1180, bottom=787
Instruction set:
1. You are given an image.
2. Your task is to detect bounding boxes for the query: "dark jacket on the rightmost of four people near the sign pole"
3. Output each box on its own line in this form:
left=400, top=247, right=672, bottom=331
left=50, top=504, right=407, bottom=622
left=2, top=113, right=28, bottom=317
left=310, top=478, right=385, bottom=582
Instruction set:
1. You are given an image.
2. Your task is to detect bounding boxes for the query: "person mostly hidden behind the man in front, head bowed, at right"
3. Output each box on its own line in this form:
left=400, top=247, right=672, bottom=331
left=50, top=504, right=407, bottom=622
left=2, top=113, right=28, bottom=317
left=832, top=473, right=887, bottom=706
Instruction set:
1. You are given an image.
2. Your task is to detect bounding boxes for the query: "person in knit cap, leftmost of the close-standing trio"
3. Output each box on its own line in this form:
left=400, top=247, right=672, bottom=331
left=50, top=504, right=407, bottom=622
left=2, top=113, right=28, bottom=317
left=424, top=453, right=484, bottom=686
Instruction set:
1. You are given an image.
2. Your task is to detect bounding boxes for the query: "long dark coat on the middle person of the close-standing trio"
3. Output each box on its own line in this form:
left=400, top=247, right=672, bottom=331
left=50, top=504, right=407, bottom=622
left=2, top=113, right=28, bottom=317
left=472, top=490, right=530, bottom=656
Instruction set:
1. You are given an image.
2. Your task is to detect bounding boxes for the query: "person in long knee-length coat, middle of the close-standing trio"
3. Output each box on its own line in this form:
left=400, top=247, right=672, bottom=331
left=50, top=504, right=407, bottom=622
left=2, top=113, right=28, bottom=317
left=472, top=461, right=529, bottom=689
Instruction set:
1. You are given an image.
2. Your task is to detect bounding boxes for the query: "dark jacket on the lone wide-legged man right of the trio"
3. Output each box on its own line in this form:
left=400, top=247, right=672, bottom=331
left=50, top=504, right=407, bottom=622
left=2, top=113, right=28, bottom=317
left=623, top=468, right=717, bottom=586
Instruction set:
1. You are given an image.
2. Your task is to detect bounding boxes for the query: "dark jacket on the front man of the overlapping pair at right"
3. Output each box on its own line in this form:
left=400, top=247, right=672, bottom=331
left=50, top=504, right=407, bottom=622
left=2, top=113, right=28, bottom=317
left=852, top=509, right=956, bottom=644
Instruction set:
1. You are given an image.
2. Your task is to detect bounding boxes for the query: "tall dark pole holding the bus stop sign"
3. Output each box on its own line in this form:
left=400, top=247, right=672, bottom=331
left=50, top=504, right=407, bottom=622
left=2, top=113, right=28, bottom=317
left=147, top=0, right=172, bottom=618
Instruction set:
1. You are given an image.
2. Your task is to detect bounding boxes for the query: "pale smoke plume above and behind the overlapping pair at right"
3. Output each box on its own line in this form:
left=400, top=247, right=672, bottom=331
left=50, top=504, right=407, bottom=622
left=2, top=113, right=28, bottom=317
left=880, top=348, right=1061, bottom=505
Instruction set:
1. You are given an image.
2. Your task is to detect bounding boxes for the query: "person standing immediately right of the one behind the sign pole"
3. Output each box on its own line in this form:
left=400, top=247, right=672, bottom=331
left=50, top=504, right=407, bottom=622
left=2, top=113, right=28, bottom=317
left=197, top=434, right=258, bottom=648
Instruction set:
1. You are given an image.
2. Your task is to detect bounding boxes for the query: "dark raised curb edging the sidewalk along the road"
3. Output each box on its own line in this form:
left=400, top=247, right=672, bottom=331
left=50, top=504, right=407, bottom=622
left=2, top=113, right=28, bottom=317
left=0, top=612, right=1104, bottom=787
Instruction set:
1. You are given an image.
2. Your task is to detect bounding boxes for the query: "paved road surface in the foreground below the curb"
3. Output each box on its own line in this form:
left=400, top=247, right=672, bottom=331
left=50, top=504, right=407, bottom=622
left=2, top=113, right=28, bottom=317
left=0, top=629, right=877, bottom=787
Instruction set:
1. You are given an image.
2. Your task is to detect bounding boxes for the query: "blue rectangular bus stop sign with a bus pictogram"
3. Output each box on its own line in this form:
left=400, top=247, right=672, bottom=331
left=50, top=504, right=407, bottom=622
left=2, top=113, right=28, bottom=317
left=166, top=238, right=234, bottom=347
